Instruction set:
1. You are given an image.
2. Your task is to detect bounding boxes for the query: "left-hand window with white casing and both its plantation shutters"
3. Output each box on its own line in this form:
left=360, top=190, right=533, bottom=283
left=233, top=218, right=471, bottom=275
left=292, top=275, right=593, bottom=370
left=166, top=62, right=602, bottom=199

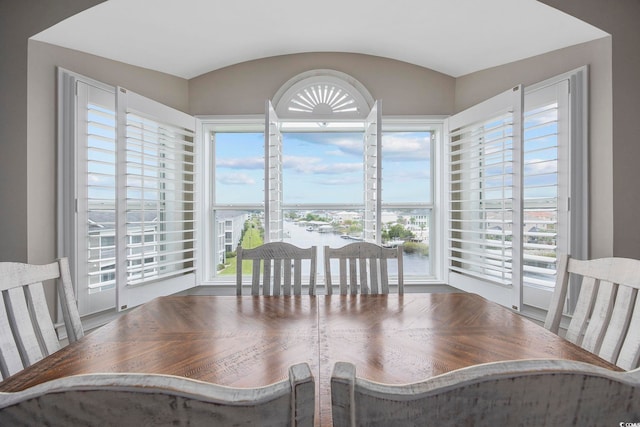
left=58, top=70, right=196, bottom=315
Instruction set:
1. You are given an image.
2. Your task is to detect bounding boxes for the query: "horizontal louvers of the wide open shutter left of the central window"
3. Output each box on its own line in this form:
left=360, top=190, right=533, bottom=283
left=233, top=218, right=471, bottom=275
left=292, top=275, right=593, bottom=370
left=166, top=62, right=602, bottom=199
left=126, top=111, right=196, bottom=285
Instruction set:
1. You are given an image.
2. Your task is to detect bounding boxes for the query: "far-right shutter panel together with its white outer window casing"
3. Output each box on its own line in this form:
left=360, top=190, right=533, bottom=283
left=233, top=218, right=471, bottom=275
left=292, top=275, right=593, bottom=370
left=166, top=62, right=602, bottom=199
left=523, top=72, right=589, bottom=312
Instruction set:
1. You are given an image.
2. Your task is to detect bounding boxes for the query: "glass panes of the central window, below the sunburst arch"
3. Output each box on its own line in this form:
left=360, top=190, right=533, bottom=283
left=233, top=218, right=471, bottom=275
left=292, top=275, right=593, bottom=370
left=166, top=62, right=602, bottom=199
left=203, top=119, right=440, bottom=281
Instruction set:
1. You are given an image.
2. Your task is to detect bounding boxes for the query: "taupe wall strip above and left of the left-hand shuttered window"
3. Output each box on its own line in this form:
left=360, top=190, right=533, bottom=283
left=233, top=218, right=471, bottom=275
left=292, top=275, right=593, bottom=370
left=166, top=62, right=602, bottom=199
left=26, top=40, right=188, bottom=263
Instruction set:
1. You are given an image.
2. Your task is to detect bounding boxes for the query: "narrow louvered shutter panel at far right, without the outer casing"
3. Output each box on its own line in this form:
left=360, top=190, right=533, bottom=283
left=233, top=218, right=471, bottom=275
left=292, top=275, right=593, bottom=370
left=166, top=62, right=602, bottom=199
left=523, top=80, right=569, bottom=287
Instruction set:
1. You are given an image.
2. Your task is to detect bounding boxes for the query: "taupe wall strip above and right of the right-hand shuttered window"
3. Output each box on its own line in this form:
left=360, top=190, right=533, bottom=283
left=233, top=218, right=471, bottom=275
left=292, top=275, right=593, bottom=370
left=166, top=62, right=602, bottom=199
left=455, top=37, right=614, bottom=257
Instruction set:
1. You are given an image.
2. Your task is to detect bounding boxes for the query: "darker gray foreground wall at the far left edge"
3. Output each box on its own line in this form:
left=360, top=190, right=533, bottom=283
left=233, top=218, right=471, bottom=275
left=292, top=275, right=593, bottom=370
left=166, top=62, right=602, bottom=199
left=0, top=0, right=102, bottom=262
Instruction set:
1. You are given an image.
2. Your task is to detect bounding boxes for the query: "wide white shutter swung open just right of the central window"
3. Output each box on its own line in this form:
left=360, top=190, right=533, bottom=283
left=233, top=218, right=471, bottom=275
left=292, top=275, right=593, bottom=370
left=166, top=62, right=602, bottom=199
left=446, top=86, right=523, bottom=310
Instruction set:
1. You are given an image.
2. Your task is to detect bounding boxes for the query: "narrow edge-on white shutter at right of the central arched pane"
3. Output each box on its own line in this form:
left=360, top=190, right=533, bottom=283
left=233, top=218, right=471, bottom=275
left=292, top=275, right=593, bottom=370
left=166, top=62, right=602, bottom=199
left=363, top=101, right=382, bottom=243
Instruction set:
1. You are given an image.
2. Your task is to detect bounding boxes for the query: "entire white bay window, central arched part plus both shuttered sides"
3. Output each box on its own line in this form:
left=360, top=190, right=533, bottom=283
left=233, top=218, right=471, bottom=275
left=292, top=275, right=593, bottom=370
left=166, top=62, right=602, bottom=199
left=58, top=69, right=588, bottom=315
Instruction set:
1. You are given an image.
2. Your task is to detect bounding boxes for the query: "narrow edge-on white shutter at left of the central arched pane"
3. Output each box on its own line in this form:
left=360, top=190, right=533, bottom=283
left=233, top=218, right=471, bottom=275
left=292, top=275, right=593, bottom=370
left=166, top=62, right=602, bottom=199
left=264, top=101, right=284, bottom=242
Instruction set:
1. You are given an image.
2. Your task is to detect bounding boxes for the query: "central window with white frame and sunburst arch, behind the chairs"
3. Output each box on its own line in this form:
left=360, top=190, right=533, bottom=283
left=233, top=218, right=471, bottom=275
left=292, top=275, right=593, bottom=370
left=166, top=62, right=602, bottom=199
left=202, top=70, right=441, bottom=282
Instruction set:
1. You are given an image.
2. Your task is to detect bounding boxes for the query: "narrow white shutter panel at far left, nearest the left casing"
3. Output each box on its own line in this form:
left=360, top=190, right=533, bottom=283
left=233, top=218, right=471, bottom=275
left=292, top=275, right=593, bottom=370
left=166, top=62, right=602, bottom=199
left=72, top=81, right=117, bottom=315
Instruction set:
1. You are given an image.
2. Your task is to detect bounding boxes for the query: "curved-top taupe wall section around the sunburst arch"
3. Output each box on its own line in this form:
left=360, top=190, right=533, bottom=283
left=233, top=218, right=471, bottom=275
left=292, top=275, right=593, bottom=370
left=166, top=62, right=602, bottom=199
left=189, top=53, right=455, bottom=115
